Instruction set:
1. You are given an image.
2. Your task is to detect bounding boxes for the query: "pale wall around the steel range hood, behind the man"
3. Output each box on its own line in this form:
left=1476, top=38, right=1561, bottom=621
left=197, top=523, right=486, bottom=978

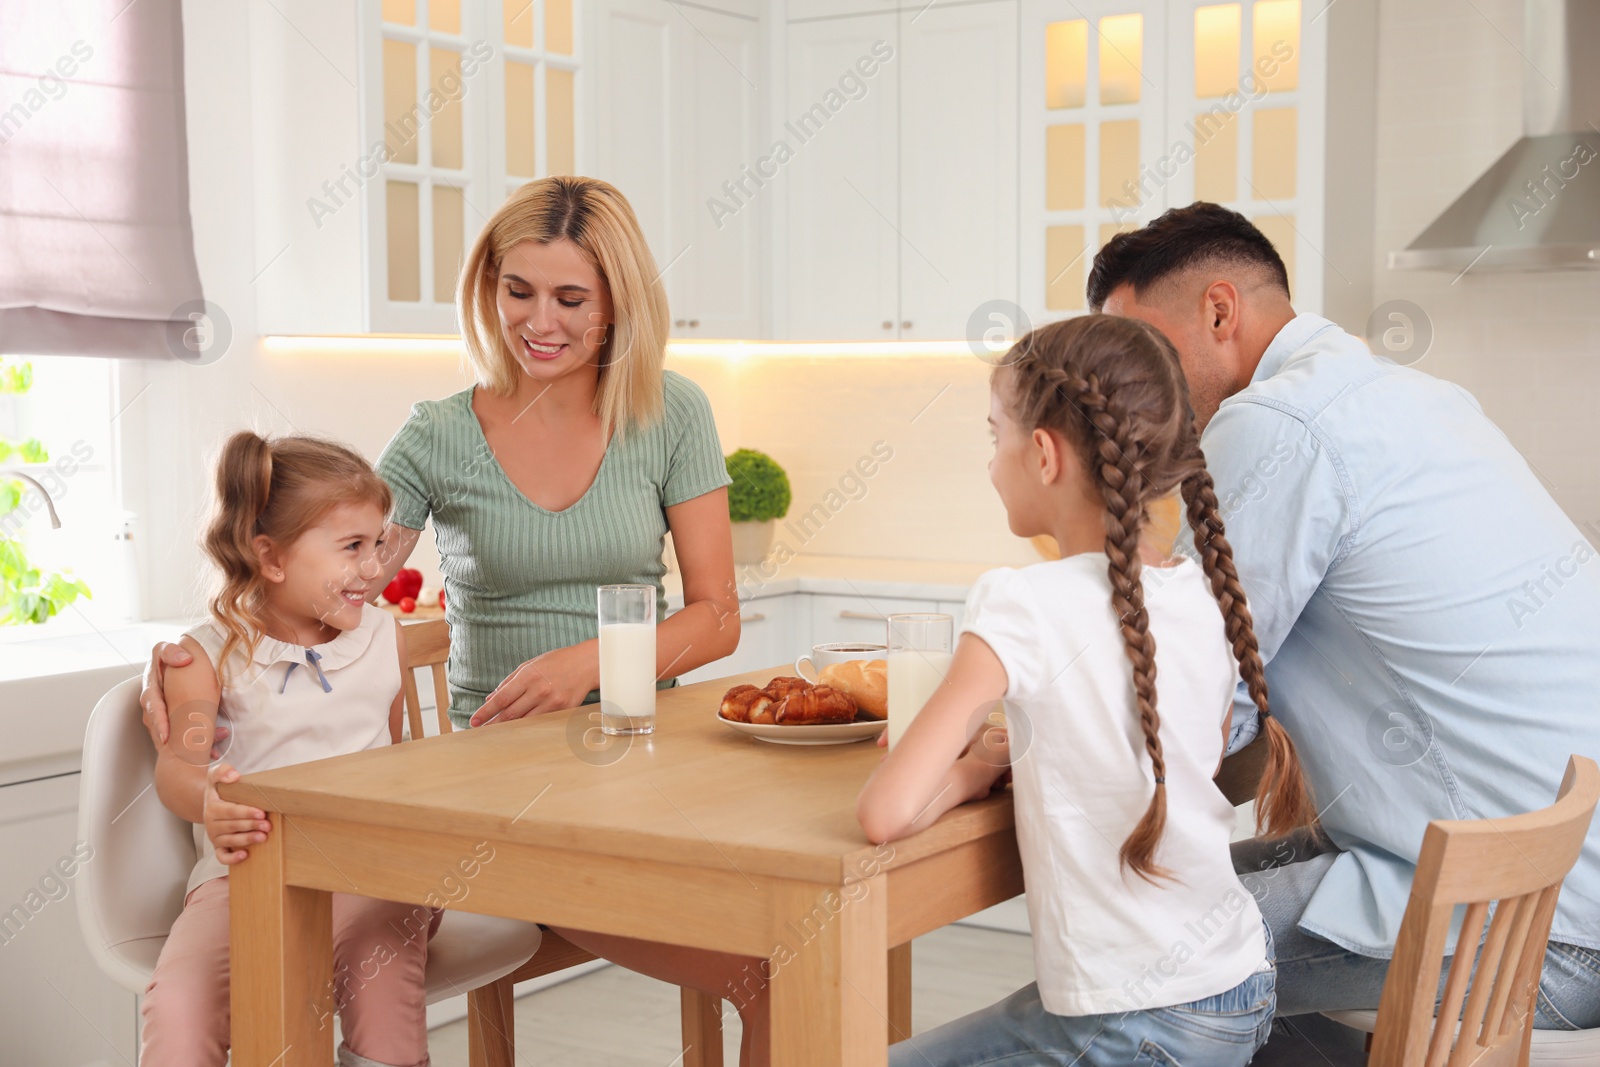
left=1373, top=0, right=1600, bottom=536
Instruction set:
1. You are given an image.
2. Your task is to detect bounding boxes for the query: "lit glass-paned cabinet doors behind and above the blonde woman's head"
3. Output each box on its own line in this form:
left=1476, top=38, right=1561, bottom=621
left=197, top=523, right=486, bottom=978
left=362, top=0, right=578, bottom=333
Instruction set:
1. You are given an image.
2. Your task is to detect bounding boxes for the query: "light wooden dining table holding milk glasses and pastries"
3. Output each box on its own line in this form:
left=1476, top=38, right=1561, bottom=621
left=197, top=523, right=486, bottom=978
left=219, top=665, right=1022, bottom=1067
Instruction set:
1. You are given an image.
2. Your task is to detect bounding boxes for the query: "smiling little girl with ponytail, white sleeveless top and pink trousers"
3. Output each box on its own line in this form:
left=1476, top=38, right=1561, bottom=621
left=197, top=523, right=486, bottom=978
left=139, top=432, right=437, bottom=1067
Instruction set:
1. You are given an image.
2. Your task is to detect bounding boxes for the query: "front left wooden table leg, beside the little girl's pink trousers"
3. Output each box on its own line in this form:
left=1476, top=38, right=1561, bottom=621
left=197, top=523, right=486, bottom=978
left=229, top=813, right=334, bottom=1067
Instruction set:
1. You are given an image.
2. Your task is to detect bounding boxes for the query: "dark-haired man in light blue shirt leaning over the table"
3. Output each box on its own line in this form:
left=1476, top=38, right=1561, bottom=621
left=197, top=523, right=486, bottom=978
left=1088, top=203, right=1600, bottom=1062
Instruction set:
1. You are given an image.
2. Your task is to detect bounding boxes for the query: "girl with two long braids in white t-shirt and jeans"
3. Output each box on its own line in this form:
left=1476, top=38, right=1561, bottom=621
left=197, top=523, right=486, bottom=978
left=858, top=315, right=1315, bottom=1067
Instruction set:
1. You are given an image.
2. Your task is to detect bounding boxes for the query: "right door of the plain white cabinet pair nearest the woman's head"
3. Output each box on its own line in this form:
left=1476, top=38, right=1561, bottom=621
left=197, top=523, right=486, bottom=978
left=656, top=5, right=758, bottom=338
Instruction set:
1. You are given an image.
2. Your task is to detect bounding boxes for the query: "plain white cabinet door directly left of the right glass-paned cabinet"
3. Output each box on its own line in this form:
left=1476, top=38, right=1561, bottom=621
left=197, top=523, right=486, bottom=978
left=899, top=0, right=1018, bottom=339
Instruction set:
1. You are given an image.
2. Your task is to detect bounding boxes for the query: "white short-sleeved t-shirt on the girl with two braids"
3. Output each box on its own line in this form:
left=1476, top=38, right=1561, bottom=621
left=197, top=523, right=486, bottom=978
left=962, top=552, right=1266, bottom=1016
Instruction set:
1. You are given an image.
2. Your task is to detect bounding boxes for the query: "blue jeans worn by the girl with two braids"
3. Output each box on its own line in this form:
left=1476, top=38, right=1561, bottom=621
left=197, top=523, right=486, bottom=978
left=890, top=931, right=1274, bottom=1067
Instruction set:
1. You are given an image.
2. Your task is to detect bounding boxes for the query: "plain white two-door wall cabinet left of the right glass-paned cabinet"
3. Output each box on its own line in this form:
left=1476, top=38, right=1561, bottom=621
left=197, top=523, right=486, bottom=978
left=782, top=0, right=1018, bottom=341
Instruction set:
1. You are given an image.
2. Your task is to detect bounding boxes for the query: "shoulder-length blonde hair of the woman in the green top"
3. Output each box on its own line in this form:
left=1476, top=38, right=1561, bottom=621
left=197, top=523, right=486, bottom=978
left=456, top=176, right=667, bottom=435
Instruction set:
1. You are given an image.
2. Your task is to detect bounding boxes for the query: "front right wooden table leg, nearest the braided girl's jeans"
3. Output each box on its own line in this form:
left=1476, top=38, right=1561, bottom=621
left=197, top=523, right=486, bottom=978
left=770, top=875, right=888, bottom=1067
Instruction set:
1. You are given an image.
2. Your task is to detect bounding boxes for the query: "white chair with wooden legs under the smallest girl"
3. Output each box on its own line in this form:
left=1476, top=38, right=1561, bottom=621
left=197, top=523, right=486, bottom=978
left=77, top=678, right=550, bottom=1065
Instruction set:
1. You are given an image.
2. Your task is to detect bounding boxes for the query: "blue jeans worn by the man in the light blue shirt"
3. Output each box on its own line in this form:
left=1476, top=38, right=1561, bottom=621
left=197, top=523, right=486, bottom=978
left=1234, top=835, right=1600, bottom=1030
